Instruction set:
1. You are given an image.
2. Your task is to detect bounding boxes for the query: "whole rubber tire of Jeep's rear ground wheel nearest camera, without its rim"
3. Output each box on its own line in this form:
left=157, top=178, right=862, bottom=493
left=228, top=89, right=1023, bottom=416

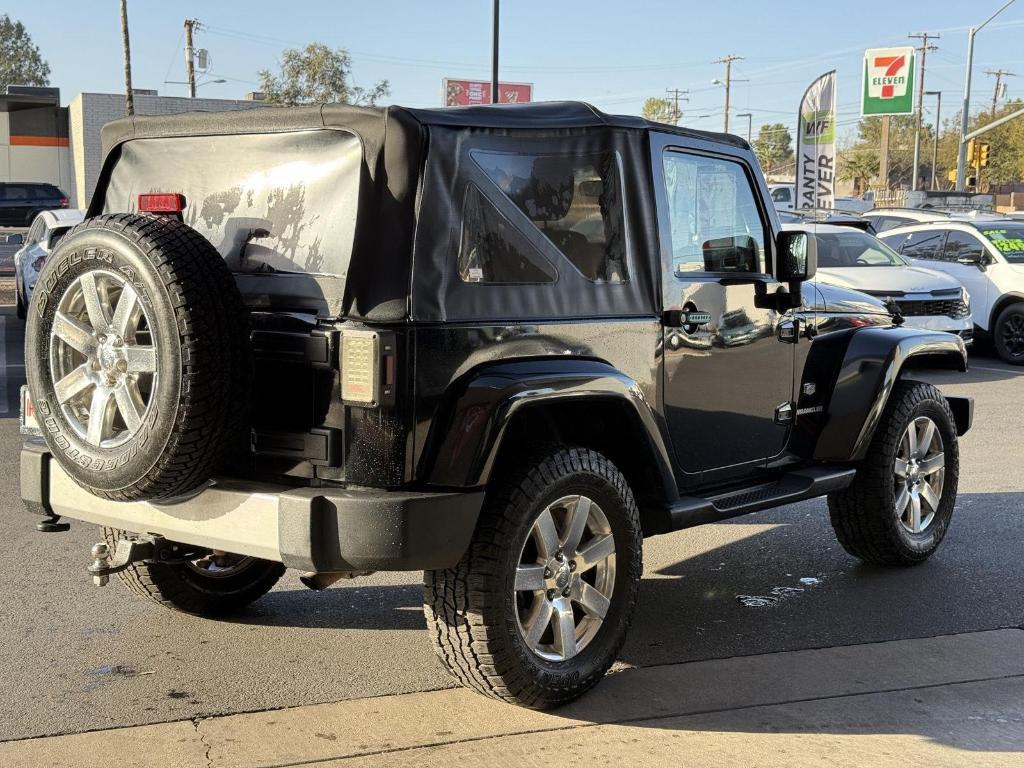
left=424, top=447, right=643, bottom=710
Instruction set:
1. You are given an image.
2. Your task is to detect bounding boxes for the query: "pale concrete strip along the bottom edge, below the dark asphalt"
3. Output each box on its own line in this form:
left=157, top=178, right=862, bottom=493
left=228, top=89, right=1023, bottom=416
left=0, top=630, right=1024, bottom=768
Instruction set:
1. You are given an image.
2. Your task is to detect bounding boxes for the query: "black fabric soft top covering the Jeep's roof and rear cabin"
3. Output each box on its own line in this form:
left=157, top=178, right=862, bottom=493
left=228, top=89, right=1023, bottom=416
left=89, top=101, right=749, bottom=322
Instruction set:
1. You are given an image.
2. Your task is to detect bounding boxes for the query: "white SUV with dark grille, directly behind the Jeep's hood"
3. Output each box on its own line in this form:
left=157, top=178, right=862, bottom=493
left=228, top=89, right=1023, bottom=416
left=782, top=224, right=974, bottom=343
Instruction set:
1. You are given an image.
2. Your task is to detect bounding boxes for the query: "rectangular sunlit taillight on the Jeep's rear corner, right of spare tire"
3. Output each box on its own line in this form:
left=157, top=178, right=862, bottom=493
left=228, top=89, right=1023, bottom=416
left=339, top=330, right=396, bottom=407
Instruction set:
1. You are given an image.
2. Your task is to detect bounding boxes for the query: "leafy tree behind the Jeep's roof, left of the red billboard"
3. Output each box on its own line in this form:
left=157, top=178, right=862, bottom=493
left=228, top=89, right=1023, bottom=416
left=259, top=43, right=391, bottom=106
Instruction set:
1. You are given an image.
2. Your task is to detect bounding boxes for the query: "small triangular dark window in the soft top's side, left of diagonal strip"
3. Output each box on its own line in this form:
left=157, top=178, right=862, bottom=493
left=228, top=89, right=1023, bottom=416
left=459, top=184, right=556, bottom=285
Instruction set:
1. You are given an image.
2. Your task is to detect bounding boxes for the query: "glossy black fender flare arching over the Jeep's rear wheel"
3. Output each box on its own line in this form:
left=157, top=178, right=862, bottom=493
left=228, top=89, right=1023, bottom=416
left=418, top=357, right=678, bottom=499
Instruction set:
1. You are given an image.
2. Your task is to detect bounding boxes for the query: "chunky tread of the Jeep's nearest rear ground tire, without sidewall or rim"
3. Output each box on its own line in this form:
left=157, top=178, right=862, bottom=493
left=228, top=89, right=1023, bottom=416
left=423, top=447, right=642, bottom=709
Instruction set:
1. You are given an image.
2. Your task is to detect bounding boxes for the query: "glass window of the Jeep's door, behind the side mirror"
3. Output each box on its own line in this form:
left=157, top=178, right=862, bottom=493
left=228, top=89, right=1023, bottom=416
left=663, top=151, right=765, bottom=274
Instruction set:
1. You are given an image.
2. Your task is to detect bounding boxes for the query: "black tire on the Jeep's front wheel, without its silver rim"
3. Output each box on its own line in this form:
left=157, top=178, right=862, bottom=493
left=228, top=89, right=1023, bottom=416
left=828, top=380, right=959, bottom=565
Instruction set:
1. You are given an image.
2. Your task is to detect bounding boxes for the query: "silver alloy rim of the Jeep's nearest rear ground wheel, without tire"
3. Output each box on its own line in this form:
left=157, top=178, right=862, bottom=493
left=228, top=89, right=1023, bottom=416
left=514, top=496, right=615, bottom=662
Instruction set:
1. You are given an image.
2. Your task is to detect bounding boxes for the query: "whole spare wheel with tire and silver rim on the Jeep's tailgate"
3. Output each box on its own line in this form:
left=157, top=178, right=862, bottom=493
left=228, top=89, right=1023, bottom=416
left=26, top=214, right=251, bottom=501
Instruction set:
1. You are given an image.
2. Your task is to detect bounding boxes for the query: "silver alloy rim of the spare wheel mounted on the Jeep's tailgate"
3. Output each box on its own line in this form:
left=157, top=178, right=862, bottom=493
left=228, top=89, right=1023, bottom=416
left=50, top=270, right=157, bottom=449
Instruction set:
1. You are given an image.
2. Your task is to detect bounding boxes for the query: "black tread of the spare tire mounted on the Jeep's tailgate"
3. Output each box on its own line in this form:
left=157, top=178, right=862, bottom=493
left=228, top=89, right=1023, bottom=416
left=40, top=213, right=252, bottom=502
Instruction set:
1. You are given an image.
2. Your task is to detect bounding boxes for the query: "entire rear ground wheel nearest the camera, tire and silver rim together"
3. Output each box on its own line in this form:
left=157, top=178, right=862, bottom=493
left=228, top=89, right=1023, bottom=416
left=424, top=447, right=642, bottom=709
